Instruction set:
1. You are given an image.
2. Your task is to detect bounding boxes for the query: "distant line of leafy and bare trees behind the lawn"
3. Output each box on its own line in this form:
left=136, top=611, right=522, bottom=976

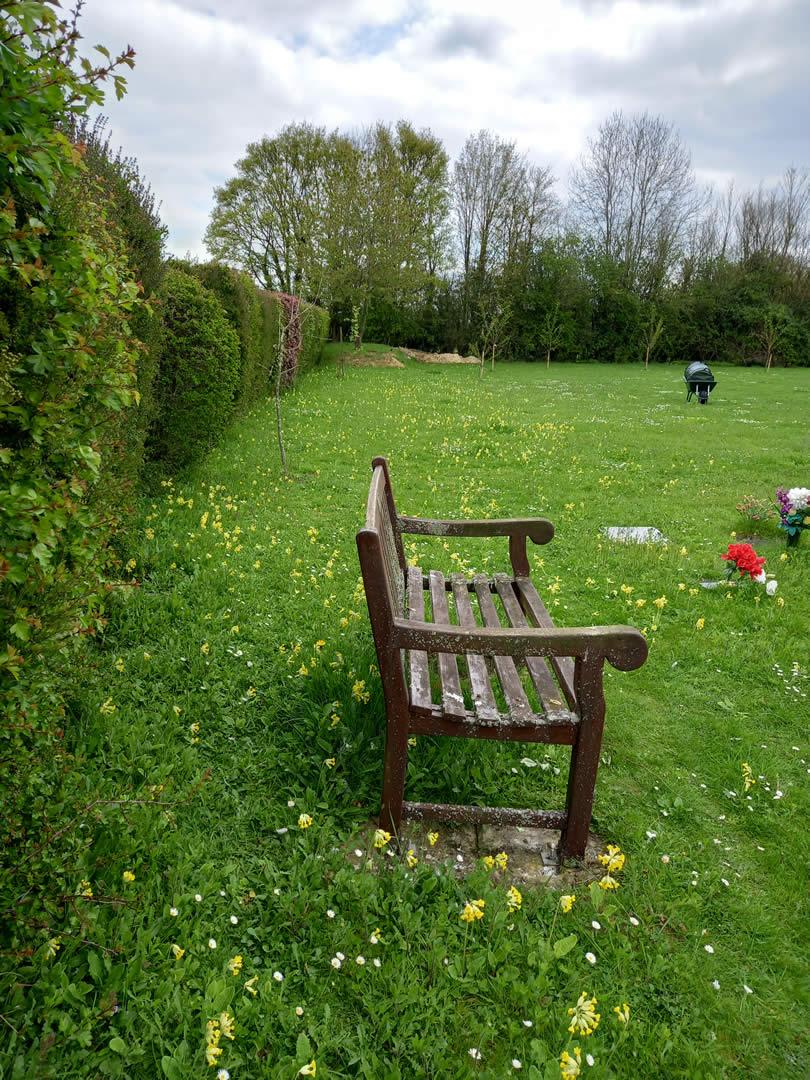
left=205, top=111, right=810, bottom=366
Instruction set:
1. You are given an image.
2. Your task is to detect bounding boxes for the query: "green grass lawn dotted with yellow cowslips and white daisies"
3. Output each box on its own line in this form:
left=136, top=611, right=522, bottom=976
left=7, top=361, right=810, bottom=1080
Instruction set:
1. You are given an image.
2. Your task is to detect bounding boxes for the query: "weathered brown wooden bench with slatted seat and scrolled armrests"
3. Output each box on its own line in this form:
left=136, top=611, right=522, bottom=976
left=357, top=458, right=647, bottom=859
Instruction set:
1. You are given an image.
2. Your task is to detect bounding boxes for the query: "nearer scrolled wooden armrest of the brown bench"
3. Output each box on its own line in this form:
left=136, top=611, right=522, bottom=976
left=392, top=618, right=647, bottom=672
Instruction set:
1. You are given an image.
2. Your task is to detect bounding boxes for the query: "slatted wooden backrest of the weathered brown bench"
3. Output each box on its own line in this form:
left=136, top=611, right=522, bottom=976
left=357, top=458, right=406, bottom=616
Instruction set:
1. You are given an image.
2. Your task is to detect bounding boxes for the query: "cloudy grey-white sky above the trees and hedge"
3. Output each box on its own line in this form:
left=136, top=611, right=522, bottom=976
left=79, top=0, right=810, bottom=257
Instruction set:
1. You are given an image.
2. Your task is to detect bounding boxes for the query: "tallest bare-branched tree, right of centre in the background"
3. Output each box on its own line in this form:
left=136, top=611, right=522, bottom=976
left=570, top=111, right=702, bottom=296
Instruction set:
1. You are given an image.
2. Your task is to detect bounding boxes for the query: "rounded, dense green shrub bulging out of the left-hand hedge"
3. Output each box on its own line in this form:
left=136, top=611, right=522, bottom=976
left=149, top=267, right=240, bottom=468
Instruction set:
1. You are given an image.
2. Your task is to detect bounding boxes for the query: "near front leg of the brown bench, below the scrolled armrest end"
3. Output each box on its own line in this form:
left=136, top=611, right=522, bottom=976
left=559, top=659, right=605, bottom=860
